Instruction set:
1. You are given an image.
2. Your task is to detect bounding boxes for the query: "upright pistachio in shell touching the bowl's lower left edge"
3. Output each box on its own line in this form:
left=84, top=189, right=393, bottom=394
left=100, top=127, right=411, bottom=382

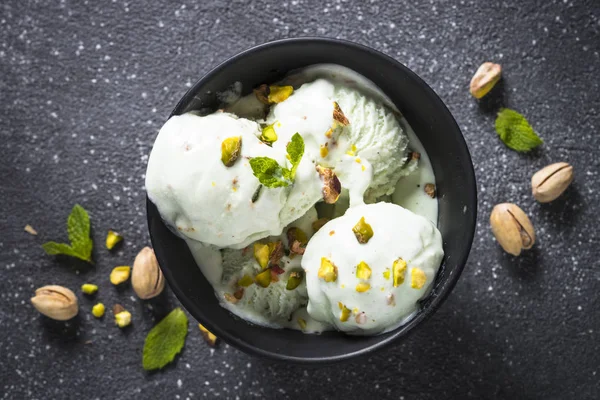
left=131, top=247, right=165, bottom=300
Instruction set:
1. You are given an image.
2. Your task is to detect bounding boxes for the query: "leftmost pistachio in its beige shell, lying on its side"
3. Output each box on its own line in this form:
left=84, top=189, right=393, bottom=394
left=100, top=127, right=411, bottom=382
left=31, top=285, right=79, bottom=321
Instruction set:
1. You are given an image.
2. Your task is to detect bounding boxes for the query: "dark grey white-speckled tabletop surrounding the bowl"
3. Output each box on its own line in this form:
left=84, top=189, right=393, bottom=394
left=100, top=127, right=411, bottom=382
left=0, top=0, right=600, bottom=399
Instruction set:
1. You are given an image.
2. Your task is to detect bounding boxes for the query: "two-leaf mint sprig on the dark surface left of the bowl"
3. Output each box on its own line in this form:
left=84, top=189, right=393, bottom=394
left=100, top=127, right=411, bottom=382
left=42, top=204, right=94, bottom=264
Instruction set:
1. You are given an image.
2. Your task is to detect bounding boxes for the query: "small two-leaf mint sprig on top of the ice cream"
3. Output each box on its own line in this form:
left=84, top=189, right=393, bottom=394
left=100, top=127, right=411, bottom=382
left=250, top=133, right=304, bottom=188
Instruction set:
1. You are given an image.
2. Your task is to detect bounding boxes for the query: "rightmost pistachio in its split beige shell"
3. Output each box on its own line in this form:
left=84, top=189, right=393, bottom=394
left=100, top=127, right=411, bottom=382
left=531, top=162, right=574, bottom=203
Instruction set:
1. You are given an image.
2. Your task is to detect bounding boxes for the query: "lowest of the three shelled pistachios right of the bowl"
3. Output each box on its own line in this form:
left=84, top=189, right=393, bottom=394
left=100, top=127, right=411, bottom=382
left=490, top=203, right=535, bottom=256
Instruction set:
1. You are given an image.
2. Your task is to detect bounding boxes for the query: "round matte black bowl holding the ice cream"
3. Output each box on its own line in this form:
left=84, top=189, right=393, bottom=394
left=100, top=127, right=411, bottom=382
left=147, top=38, right=477, bottom=364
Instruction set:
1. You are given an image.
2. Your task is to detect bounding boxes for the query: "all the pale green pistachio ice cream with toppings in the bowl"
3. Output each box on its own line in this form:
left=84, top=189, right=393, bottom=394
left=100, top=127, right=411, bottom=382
left=146, top=65, right=443, bottom=334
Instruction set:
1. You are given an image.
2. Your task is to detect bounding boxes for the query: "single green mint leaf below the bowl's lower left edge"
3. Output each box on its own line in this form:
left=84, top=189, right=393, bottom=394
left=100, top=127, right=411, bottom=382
left=142, top=308, right=188, bottom=371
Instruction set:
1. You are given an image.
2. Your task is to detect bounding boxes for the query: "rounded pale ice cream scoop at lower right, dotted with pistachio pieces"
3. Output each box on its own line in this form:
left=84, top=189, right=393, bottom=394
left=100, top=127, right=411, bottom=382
left=302, top=203, right=444, bottom=335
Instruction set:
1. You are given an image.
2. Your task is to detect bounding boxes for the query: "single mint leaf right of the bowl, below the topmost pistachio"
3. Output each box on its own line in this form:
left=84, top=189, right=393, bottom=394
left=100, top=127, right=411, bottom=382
left=496, top=108, right=544, bottom=151
